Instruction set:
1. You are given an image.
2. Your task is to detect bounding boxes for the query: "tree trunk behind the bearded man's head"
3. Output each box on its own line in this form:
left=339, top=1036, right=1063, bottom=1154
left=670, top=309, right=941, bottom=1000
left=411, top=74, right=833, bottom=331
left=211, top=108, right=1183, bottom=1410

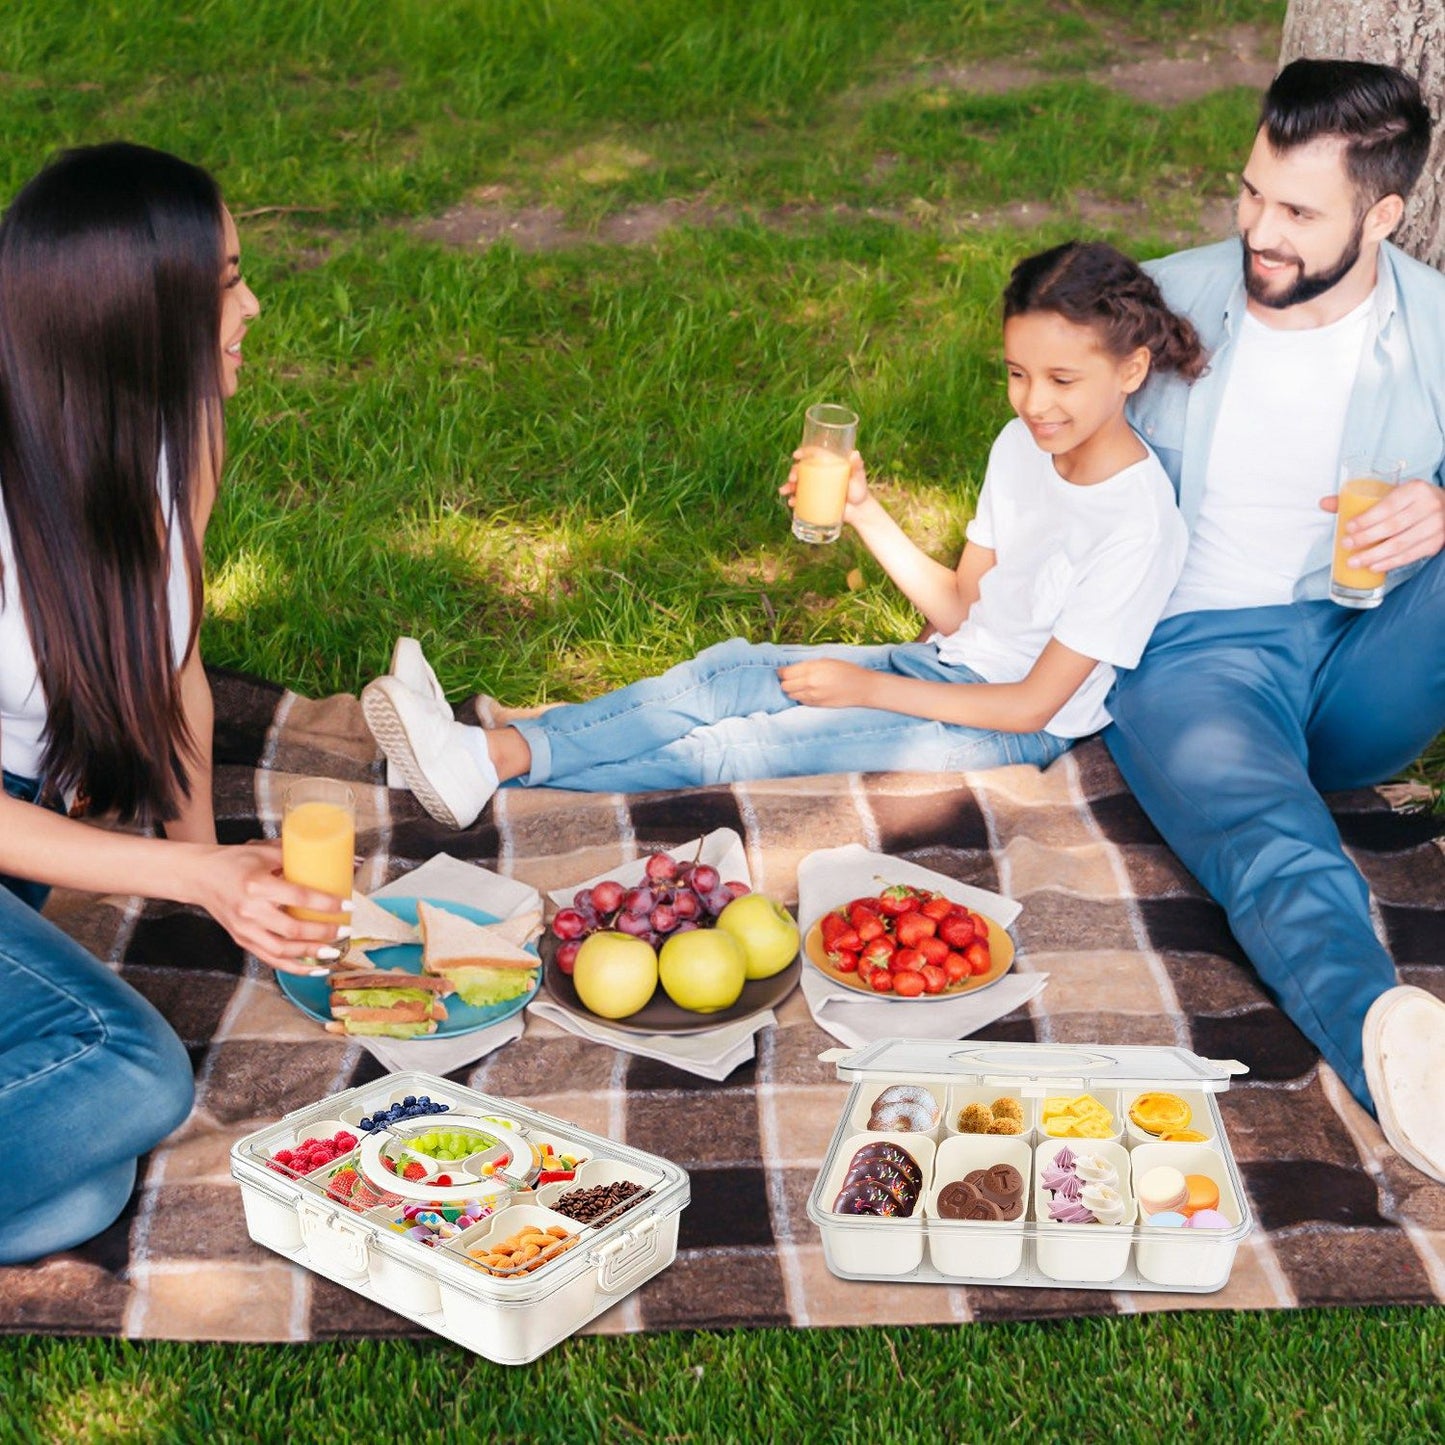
left=1279, top=0, right=1445, bottom=270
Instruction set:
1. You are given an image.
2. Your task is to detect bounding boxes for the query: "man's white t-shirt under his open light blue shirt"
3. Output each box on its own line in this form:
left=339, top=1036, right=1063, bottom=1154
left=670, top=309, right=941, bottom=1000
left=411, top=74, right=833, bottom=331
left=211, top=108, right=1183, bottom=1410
left=1165, top=292, right=1376, bottom=617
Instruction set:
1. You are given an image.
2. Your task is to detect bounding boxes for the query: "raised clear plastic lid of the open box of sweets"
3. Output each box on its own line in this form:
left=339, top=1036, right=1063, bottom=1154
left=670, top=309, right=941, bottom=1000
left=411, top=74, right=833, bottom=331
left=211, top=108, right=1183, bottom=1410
left=818, top=1039, right=1248, bottom=1094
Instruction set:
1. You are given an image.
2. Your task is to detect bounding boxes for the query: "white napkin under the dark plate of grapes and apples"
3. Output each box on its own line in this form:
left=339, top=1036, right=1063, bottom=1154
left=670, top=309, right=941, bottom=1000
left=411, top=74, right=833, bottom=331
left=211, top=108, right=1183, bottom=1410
left=543, top=828, right=777, bottom=1082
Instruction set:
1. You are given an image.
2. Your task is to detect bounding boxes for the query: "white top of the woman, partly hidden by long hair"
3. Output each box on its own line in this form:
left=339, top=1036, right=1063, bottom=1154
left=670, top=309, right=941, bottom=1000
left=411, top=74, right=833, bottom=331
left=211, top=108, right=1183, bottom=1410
left=0, top=455, right=191, bottom=777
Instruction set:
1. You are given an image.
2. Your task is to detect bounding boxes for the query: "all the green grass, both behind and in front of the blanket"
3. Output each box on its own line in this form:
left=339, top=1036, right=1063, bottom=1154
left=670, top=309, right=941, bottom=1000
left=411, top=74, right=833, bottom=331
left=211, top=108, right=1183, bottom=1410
left=0, top=0, right=1445, bottom=1442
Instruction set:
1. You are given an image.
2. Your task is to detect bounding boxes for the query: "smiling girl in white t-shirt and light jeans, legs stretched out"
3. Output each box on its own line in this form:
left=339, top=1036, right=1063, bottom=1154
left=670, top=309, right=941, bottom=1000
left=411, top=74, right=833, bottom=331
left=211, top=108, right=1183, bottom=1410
left=361, top=241, right=1204, bottom=828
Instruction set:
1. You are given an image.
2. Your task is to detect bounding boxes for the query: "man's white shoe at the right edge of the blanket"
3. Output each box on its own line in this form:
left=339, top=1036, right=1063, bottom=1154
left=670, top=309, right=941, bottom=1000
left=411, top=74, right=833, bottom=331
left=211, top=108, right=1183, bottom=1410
left=1364, top=984, right=1445, bottom=1182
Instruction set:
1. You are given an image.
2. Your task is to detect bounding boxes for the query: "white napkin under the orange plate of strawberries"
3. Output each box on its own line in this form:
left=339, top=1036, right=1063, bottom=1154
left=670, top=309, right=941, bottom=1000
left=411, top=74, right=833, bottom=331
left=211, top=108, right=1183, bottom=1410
left=798, top=842, right=1049, bottom=1049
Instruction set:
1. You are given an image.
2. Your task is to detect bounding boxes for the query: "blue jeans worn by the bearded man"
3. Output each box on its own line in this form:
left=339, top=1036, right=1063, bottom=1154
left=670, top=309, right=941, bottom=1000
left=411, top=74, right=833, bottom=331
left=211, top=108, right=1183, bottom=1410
left=1104, top=553, right=1445, bottom=1108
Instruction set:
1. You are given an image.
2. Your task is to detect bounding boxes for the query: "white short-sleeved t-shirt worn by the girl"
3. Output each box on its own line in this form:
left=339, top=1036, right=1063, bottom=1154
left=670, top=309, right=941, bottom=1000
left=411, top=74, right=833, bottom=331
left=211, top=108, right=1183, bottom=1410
left=938, top=419, right=1189, bottom=737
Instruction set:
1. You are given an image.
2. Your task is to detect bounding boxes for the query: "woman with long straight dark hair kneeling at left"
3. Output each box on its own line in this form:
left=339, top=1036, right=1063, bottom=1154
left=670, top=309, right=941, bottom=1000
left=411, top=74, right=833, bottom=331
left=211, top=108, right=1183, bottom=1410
left=0, top=143, right=349, bottom=1263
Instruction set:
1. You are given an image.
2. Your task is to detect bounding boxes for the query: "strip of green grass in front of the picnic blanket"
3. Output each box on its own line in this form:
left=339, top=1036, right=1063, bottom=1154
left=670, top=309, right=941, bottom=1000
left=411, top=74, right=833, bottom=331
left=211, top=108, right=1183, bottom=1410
left=8, top=1309, right=1445, bottom=1445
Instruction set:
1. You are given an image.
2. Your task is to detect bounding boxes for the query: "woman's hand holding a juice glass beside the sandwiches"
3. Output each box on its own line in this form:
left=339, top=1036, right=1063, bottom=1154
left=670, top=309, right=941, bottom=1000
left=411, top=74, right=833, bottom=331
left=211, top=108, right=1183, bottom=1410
left=188, top=842, right=350, bottom=974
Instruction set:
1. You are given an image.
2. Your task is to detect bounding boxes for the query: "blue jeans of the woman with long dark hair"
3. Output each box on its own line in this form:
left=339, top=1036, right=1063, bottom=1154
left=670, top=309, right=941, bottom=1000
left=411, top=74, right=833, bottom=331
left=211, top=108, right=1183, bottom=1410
left=0, top=773, right=195, bottom=1264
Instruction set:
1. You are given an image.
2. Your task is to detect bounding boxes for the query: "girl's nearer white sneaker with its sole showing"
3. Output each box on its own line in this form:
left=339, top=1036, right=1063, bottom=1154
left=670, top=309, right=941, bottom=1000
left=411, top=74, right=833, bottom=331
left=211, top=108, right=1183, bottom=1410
left=361, top=676, right=499, bottom=828
